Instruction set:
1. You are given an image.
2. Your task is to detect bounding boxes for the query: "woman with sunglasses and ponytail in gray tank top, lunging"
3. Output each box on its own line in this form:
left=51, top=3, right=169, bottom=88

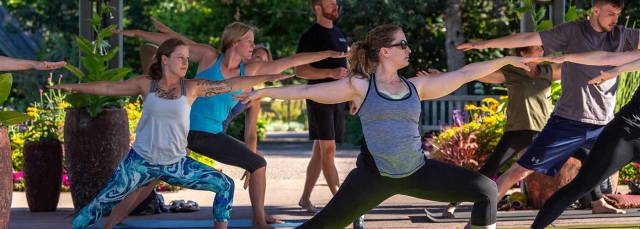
left=235, top=25, right=536, bottom=228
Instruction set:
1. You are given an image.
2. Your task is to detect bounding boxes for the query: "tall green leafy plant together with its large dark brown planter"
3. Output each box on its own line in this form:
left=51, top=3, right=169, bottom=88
left=64, top=3, right=131, bottom=210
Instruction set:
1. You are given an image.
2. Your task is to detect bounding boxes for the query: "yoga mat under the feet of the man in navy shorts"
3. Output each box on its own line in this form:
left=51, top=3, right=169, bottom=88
left=424, top=208, right=640, bottom=223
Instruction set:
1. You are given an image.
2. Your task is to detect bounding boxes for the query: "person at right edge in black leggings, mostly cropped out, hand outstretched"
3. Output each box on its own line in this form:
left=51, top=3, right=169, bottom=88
left=531, top=47, right=640, bottom=229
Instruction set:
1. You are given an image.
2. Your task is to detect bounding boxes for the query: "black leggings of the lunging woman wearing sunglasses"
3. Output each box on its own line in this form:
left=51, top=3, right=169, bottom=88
left=297, top=159, right=498, bottom=229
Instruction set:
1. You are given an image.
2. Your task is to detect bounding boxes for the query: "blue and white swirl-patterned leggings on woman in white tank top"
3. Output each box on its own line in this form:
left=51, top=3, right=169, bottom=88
left=71, top=149, right=235, bottom=229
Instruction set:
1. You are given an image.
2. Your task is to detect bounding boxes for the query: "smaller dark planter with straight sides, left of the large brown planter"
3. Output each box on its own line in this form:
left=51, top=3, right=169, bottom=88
left=22, top=140, right=62, bottom=212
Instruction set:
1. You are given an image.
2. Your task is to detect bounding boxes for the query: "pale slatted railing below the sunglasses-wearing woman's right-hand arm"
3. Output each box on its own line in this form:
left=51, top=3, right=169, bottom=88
left=422, top=95, right=500, bottom=133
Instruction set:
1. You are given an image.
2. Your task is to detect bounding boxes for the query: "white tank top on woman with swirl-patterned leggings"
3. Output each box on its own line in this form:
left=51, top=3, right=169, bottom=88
left=131, top=78, right=191, bottom=165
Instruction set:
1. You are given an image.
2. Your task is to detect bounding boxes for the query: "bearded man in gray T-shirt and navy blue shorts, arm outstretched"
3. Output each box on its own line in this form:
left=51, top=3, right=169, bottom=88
left=458, top=0, right=640, bottom=214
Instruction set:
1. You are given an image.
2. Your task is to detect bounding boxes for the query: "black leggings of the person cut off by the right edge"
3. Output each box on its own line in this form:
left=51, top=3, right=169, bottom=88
left=531, top=117, right=640, bottom=229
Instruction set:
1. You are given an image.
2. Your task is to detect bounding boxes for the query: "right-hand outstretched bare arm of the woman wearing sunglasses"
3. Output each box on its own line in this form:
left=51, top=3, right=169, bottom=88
left=409, top=56, right=540, bottom=100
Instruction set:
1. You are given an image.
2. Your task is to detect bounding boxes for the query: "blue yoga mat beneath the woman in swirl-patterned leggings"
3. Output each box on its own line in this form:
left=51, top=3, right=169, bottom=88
left=95, top=220, right=306, bottom=228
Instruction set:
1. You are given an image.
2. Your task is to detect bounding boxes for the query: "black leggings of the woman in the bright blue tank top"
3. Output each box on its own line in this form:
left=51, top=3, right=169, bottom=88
left=187, top=130, right=267, bottom=173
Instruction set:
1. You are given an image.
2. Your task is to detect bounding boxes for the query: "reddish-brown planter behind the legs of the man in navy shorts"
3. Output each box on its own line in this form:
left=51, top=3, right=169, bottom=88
left=525, top=157, right=618, bottom=209
